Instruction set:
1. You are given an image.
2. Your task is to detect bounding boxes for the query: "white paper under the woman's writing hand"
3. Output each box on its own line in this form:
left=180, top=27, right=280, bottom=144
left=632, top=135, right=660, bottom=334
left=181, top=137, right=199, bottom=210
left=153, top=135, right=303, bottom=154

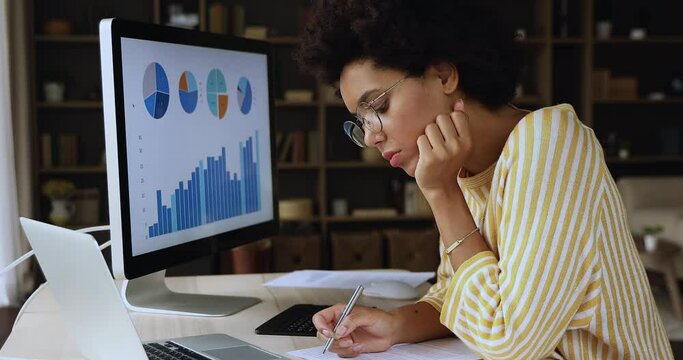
left=288, top=338, right=479, bottom=360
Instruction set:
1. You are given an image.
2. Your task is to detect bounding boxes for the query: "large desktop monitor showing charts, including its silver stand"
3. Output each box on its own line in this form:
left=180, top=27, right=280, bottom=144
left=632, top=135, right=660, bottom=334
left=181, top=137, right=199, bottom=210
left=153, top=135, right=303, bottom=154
left=100, top=19, right=279, bottom=316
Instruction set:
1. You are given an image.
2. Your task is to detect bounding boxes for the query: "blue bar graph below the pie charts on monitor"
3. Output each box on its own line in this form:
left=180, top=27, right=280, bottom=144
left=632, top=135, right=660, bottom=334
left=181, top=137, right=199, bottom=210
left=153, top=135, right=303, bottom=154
left=148, top=132, right=261, bottom=238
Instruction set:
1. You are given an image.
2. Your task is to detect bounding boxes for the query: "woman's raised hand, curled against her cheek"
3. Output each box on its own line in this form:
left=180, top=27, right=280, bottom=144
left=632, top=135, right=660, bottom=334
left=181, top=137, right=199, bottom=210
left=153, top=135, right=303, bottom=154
left=415, top=100, right=472, bottom=200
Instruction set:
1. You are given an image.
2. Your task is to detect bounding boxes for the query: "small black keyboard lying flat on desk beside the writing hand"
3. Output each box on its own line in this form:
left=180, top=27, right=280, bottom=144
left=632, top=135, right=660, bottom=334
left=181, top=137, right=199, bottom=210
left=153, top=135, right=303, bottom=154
left=254, top=304, right=329, bottom=336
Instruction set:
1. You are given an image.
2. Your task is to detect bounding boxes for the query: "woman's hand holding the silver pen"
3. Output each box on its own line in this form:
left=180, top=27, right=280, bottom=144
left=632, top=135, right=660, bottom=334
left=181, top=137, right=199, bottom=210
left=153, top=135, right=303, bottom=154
left=313, top=304, right=396, bottom=357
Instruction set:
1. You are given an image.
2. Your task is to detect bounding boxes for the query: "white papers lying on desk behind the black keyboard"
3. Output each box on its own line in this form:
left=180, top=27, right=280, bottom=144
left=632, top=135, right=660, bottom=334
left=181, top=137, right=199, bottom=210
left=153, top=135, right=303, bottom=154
left=264, top=270, right=434, bottom=289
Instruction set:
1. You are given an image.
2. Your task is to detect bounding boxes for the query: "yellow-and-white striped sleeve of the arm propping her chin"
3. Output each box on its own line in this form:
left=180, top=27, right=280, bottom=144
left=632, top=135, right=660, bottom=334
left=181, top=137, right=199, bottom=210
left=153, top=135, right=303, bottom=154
left=441, top=107, right=602, bottom=359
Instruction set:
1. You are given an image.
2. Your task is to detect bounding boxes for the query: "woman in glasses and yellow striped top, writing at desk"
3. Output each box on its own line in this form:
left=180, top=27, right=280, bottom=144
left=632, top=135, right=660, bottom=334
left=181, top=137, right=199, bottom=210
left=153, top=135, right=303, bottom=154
left=297, top=0, right=672, bottom=359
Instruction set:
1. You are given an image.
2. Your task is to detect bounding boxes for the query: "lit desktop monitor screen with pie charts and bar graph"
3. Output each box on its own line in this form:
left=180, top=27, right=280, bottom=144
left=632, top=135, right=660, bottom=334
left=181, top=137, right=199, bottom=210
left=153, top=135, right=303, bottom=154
left=121, top=38, right=273, bottom=256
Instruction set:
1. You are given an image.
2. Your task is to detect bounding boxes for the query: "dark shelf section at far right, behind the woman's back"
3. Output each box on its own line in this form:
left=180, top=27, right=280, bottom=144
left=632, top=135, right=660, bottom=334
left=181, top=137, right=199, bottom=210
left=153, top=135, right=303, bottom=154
left=583, top=0, right=683, bottom=174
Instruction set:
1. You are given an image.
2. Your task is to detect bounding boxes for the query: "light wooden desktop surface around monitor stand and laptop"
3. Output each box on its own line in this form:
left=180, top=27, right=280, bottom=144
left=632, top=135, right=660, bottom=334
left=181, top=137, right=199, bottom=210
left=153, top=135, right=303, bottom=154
left=0, top=274, right=429, bottom=359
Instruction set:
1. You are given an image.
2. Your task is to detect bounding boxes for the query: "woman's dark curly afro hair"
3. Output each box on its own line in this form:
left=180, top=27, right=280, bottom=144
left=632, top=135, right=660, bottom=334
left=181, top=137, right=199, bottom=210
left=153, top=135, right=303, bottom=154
left=295, top=0, right=520, bottom=109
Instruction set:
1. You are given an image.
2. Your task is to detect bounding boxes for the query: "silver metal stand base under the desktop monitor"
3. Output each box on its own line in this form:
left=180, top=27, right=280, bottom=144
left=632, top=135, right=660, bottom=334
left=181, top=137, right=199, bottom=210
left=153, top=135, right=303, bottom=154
left=121, top=270, right=261, bottom=316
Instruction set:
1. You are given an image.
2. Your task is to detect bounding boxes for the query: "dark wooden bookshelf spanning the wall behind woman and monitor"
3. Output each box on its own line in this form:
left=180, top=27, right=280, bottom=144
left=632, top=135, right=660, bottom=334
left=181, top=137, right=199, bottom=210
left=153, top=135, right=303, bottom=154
left=32, top=0, right=683, bottom=268
